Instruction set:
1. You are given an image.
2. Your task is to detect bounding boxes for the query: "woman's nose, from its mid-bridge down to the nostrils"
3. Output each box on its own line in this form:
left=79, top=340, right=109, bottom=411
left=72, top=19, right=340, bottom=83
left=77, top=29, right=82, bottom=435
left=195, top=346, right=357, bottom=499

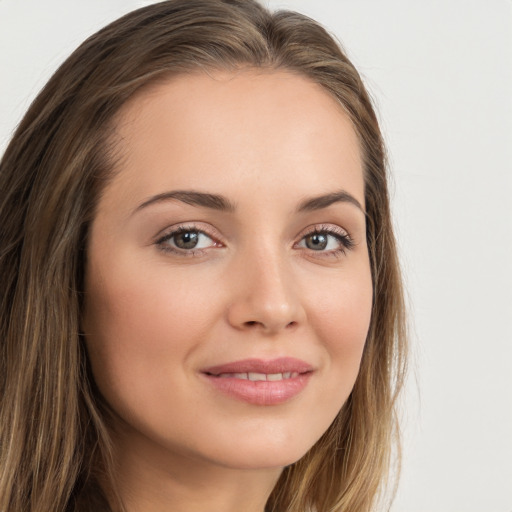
left=228, top=251, right=306, bottom=335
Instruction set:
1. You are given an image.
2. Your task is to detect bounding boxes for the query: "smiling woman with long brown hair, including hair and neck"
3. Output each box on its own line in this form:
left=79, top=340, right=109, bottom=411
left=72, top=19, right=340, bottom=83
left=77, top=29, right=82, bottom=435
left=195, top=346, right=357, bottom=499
left=0, top=0, right=405, bottom=512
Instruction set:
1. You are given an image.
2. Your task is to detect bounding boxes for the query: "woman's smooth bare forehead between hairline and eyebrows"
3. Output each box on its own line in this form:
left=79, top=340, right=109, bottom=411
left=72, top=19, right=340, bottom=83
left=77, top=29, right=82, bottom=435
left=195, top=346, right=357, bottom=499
left=108, top=69, right=364, bottom=212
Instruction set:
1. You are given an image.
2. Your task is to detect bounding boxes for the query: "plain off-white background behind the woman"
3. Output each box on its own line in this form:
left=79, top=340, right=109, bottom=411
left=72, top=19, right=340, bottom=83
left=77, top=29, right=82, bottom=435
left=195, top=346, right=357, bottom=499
left=0, top=0, right=512, bottom=512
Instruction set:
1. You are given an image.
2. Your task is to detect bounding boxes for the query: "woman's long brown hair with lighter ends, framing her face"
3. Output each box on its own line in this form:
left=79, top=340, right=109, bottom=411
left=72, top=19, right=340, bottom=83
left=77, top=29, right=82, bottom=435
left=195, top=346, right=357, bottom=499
left=0, top=0, right=406, bottom=512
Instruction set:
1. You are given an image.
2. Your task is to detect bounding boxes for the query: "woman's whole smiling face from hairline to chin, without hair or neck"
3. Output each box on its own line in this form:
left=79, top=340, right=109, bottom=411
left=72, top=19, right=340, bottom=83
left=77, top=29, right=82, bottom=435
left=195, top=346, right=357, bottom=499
left=83, top=70, right=372, bottom=468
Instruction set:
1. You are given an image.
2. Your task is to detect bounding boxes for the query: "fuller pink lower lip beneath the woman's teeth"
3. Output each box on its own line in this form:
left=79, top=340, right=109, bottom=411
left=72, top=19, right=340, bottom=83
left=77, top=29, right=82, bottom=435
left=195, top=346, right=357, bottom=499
left=204, top=372, right=312, bottom=405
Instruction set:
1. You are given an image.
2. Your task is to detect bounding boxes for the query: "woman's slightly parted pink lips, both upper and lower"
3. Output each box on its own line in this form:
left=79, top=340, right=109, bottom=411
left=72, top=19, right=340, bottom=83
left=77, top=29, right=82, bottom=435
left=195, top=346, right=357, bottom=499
left=201, top=357, right=314, bottom=405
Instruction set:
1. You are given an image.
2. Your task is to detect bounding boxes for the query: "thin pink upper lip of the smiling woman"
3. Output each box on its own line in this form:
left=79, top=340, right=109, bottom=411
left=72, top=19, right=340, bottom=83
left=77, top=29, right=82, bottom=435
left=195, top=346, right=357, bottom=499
left=202, top=357, right=314, bottom=375
